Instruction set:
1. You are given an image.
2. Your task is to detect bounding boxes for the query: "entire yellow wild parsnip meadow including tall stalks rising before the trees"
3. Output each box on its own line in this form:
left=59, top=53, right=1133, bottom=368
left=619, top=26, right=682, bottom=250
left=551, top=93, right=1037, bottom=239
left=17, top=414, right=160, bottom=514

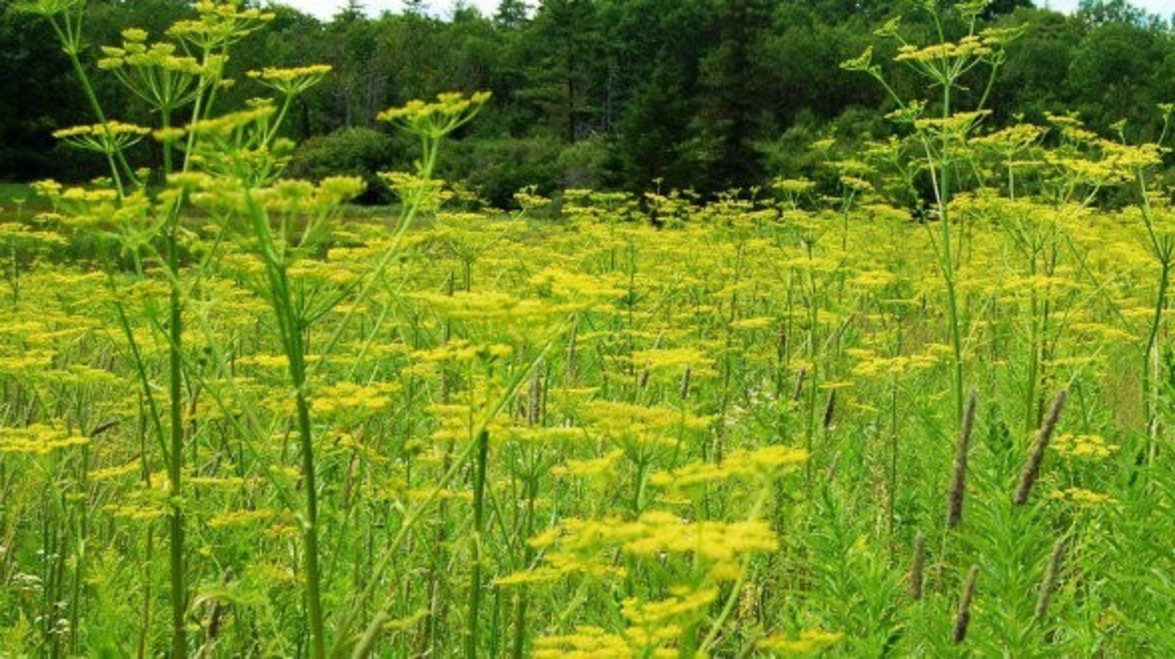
left=0, top=0, right=1175, bottom=657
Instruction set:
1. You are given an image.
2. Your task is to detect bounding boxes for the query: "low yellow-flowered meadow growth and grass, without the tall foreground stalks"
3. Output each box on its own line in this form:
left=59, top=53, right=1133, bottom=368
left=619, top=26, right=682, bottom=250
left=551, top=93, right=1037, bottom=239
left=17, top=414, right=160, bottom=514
left=0, top=183, right=1175, bottom=655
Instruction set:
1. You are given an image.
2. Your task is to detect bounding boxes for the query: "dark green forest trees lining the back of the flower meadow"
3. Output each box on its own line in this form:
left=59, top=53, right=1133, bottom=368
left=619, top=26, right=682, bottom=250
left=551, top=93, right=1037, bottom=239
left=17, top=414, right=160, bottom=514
left=0, top=0, right=1175, bottom=207
